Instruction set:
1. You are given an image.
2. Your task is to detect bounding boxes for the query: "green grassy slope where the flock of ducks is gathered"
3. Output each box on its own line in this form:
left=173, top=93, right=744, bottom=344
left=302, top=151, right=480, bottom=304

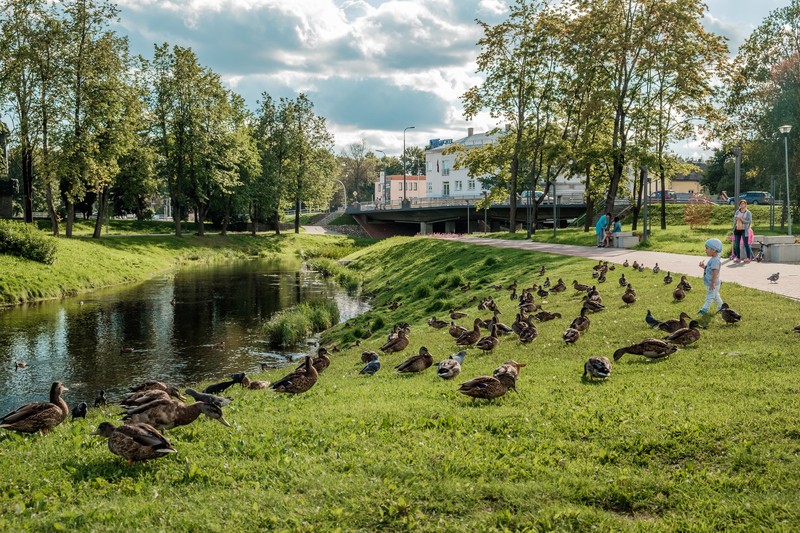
left=0, top=235, right=800, bottom=531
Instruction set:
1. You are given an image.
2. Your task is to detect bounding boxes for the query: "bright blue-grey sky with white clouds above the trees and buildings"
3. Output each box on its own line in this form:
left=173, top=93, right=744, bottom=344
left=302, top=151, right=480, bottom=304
left=114, top=0, right=789, bottom=157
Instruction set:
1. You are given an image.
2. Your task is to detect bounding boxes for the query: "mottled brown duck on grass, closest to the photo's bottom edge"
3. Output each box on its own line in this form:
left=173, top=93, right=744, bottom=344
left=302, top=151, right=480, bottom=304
left=92, top=422, right=176, bottom=465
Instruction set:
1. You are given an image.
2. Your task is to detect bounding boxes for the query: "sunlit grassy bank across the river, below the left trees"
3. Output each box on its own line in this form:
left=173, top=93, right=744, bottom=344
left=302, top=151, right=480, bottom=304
left=0, top=221, right=368, bottom=305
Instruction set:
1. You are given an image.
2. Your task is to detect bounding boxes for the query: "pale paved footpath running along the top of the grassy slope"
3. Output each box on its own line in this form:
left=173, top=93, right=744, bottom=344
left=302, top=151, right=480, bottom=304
left=444, top=237, right=800, bottom=300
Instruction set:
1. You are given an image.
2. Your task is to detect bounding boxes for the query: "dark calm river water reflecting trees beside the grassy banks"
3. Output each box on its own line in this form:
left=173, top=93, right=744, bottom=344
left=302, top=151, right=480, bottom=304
left=0, top=261, right=367, bottom=416
